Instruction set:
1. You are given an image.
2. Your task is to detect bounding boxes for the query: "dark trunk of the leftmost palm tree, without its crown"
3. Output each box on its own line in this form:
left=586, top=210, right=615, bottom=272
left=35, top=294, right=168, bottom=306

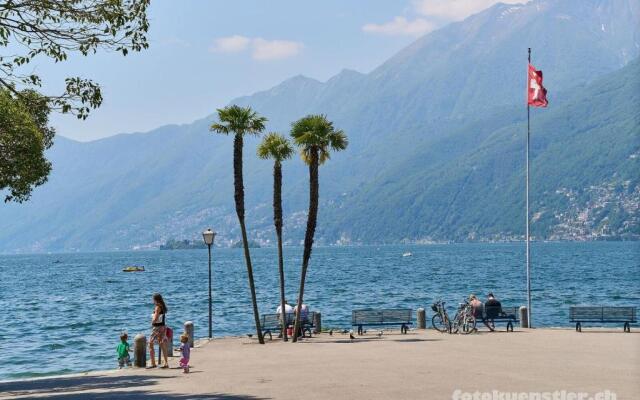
left=233, top=135, right=264, bottom=344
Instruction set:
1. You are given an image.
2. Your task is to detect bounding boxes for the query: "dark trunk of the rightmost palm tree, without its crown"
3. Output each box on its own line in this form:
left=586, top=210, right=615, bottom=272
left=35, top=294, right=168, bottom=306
left=293, top=149, right=320, bottom=343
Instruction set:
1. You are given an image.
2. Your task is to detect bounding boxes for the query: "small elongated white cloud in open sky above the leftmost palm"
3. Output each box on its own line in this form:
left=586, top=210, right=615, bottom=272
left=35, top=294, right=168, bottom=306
left=209, top=35, right=304, bottom=61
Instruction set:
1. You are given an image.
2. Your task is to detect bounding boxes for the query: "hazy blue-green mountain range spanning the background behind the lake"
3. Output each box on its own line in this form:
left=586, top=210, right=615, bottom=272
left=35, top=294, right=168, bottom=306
left=0, top=0, right=640, bottom=251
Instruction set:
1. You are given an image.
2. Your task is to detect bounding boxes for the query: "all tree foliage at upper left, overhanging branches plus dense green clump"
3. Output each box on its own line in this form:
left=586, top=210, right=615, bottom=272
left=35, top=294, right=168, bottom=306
left=0, top=0, right=150, bottom=202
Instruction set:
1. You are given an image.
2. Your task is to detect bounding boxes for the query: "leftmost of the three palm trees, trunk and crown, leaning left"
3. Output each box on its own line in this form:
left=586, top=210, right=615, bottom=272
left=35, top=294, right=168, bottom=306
left=210, top=105, right=267, bottom=344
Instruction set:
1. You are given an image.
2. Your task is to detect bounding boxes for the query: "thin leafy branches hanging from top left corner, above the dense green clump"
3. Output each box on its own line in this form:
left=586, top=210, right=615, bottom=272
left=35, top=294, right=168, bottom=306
left=0, top=0, right=150, bottom=119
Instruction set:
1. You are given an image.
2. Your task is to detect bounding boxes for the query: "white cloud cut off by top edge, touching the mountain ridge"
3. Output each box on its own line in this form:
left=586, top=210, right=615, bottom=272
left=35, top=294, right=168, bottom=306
left=413, top=0, right=528, bottom=21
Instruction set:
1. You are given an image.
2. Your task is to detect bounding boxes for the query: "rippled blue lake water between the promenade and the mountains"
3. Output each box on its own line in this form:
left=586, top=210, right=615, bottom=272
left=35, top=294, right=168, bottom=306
left=0, top=242, right=640, bottom=379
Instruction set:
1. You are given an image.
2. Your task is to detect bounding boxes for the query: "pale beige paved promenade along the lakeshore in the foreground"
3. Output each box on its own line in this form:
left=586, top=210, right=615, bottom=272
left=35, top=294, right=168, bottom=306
left=0, top=328, right=640, bottom=400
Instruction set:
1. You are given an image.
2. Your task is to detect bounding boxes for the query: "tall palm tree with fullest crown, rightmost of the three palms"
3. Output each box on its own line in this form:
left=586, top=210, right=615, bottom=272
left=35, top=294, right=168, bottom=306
left=291, top=115, right=349, bottom=342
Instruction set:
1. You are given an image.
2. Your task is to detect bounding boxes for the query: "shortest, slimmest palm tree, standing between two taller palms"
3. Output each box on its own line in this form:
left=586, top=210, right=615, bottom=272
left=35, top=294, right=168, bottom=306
left=258, top=132, right=293, bottom=342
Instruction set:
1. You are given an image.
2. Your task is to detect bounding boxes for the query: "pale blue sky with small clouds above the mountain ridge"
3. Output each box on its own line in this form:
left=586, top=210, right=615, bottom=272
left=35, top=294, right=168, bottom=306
left=29, top=0, right=522, bottom=141
